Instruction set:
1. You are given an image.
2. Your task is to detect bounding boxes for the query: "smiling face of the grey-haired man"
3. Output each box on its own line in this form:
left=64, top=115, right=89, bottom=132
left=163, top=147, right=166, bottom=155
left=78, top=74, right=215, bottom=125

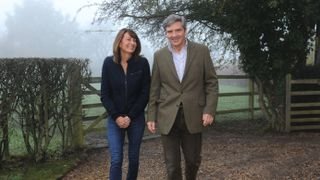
left=166, top=21, right=186, bottom=50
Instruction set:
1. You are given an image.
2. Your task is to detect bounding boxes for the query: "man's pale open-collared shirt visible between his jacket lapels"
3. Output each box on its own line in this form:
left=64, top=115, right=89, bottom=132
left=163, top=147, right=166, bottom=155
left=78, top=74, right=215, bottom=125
left=168, top=41, right=188, bottom=82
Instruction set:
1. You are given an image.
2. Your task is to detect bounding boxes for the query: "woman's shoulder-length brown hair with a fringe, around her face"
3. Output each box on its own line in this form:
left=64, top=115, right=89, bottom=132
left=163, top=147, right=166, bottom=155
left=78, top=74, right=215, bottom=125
left=113, top=28, right=141, bottom=63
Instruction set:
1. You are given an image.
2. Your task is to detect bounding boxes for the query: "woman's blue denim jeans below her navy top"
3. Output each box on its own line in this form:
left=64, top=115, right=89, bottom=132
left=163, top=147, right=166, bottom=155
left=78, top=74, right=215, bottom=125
left=107, top=114, right=145, bottom=180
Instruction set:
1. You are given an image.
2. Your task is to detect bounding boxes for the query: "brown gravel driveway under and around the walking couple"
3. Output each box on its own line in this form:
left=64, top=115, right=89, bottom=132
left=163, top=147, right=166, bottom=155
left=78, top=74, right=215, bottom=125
left=63, top=121, right=320, bottom=180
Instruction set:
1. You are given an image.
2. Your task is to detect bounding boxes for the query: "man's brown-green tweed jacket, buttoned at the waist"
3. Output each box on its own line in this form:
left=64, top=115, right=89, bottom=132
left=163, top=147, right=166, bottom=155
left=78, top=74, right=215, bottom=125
left=147, top=41, right=218, bottom=134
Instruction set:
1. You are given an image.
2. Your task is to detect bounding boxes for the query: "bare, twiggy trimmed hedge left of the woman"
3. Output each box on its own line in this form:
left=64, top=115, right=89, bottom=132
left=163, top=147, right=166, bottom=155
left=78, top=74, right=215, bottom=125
left=0, top=58, right=90, bottom=161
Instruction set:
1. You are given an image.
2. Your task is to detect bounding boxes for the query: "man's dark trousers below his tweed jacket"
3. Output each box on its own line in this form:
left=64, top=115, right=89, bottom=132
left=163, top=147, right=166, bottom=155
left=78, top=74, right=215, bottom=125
left=161, top=107, right=202, bottom=180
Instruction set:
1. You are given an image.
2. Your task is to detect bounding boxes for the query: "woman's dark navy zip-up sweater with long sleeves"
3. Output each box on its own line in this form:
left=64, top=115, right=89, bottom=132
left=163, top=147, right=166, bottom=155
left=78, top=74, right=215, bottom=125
left=101, top=56, right=150, bottom=120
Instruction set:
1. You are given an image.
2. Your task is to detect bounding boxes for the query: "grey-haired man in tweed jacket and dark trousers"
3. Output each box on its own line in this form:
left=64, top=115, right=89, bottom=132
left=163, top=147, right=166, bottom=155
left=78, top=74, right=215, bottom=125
left=147, top=15, right=218, bottom=180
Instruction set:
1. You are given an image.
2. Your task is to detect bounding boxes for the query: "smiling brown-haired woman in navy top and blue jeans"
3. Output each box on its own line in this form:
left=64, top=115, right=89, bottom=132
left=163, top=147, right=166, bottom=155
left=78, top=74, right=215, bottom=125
left=101, top=28, right=150, bottom=180
